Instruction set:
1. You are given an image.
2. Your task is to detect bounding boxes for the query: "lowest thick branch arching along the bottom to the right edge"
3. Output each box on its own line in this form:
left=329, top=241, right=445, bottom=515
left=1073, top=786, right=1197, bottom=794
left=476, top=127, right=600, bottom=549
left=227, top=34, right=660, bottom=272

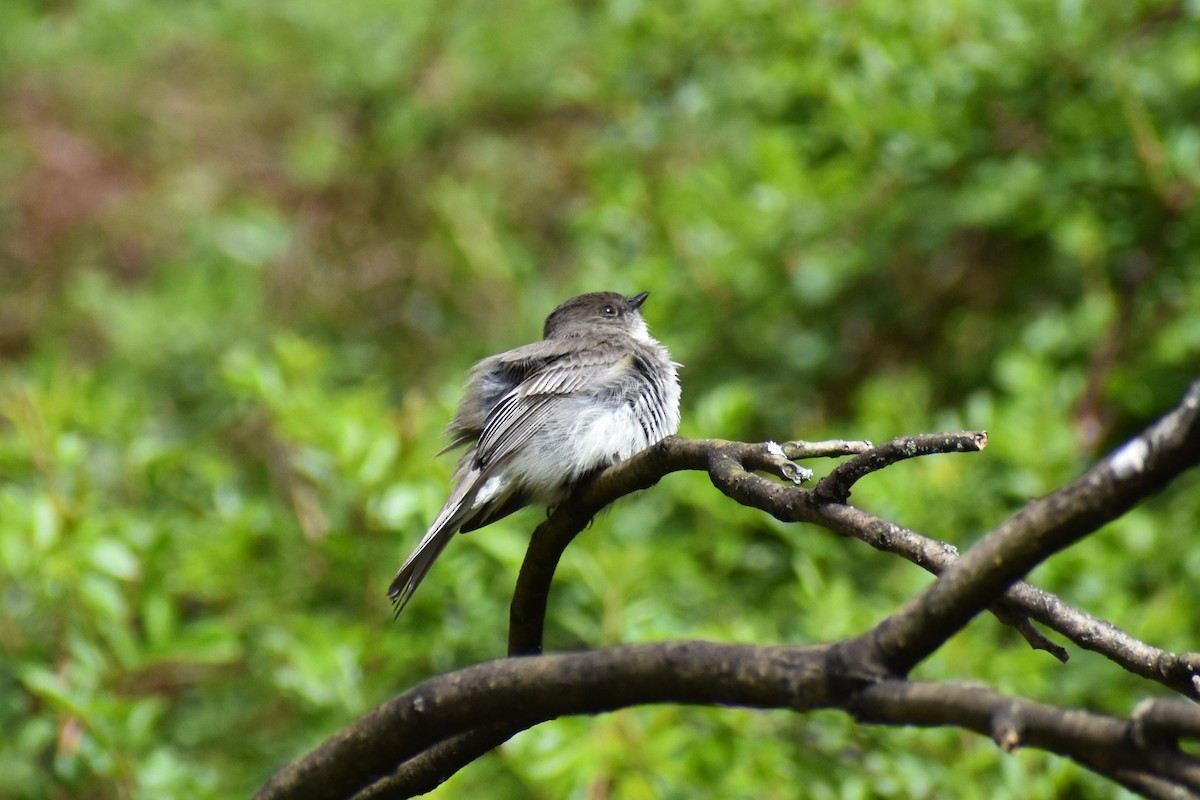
left=256, top=642, right=1200, bottom=800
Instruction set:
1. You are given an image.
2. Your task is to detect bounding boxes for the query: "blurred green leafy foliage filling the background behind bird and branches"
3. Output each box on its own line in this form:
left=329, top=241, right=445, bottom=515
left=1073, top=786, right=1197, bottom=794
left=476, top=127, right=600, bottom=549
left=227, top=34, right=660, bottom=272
left=0, top=0, right=1200, bottom=800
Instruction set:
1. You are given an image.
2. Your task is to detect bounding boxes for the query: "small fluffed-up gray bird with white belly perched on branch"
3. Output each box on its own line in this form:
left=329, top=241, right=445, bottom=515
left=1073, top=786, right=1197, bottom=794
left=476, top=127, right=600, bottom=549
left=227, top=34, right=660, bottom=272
left=388, top=291, right=679, bottom=614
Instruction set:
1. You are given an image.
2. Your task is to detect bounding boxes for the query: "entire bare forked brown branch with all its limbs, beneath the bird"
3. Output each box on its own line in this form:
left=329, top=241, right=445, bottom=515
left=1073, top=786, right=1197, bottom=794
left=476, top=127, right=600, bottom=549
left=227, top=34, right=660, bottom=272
left=257, top=381, right=1200, bottom=800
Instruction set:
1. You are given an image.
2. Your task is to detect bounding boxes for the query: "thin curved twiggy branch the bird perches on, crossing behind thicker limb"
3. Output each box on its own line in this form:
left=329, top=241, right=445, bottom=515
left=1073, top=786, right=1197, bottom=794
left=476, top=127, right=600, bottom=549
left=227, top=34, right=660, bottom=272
left=509, top=422, right=1200, bottom=699
